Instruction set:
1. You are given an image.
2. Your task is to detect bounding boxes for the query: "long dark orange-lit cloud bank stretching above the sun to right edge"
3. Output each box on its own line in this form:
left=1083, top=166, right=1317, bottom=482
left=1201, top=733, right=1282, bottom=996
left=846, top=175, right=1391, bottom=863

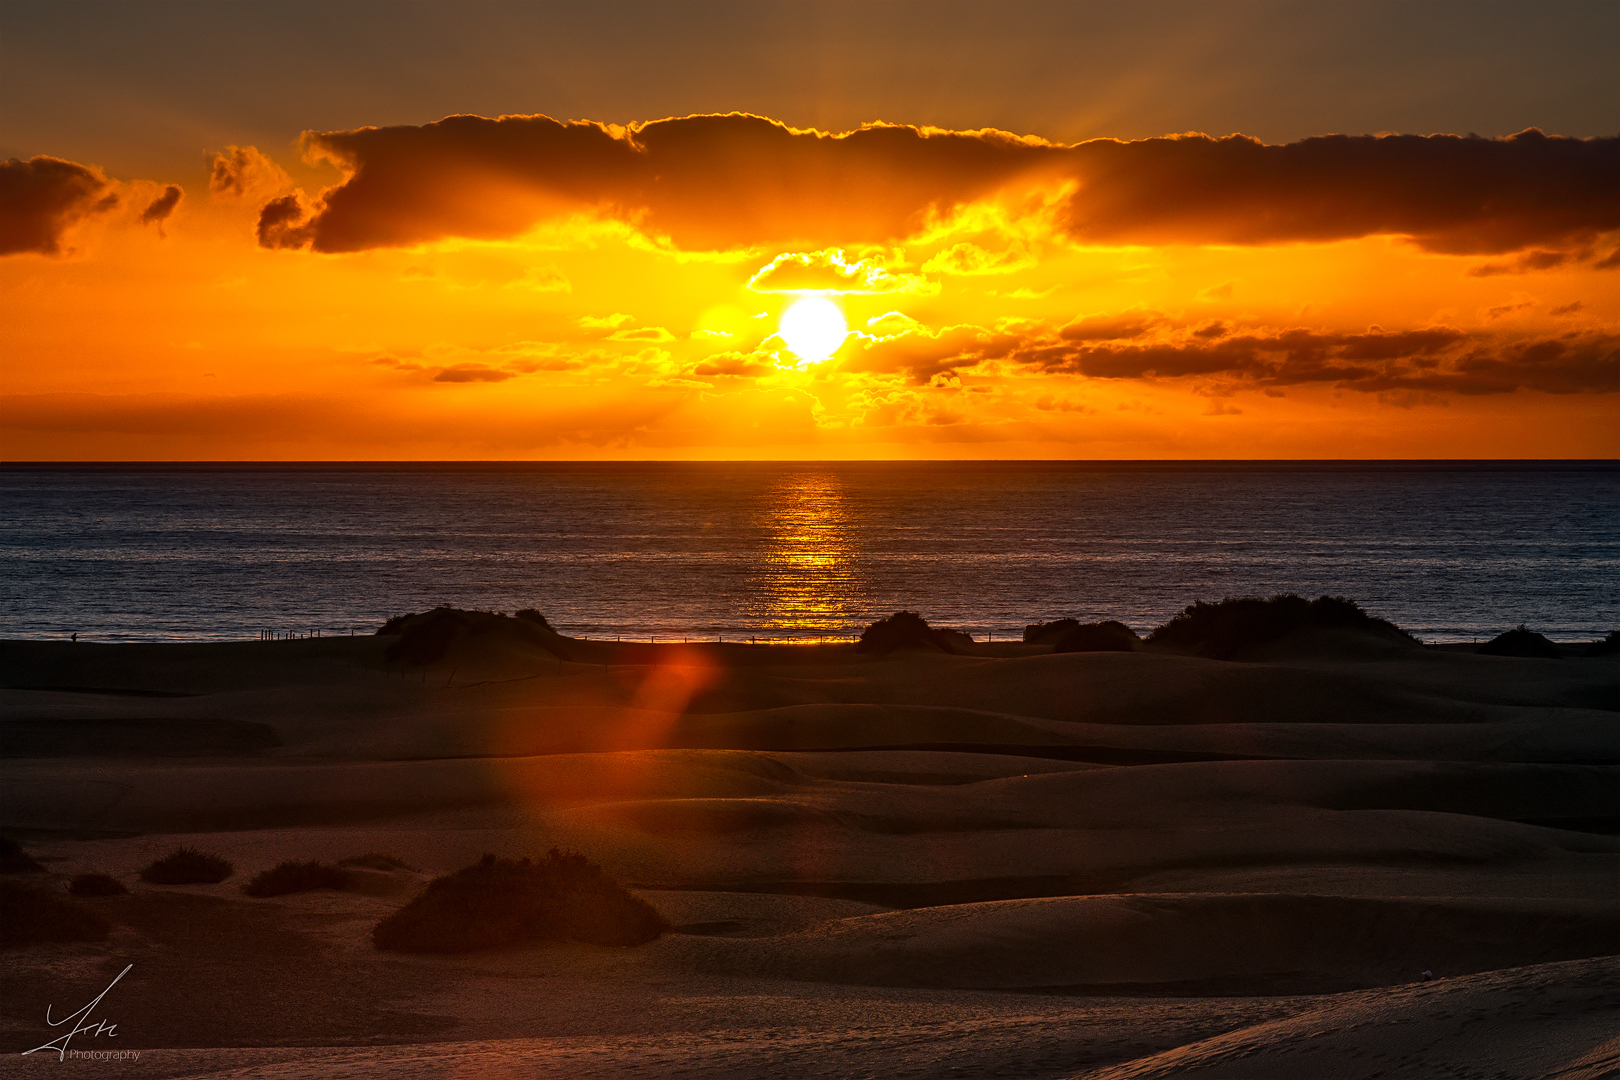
left=259, top=113, right=1620, bottom=257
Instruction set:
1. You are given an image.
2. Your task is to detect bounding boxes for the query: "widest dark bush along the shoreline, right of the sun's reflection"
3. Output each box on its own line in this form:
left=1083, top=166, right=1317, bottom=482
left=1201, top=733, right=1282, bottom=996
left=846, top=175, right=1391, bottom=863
left=1147, top=593, right=1418, bottom=659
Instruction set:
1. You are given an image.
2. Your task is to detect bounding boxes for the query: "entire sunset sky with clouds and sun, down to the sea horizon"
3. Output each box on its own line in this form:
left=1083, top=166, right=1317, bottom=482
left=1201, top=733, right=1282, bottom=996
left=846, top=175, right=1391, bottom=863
left=0, top=0, right=1620, bottom=460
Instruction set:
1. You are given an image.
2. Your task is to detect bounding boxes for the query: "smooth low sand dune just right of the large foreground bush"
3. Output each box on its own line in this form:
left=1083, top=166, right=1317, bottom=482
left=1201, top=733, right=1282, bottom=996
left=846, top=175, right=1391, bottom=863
left=664, top=894, right=1620, bottom=994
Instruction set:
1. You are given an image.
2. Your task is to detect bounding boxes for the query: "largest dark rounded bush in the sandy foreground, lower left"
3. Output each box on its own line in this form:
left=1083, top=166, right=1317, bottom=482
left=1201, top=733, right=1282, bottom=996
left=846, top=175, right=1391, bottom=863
left=371, top=848, right=669, bottom=952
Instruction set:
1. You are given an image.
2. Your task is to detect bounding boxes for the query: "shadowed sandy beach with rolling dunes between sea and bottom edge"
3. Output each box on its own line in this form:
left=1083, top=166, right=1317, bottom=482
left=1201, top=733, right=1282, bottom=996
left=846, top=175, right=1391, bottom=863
left=0, top=619, right=1620, bottom=1077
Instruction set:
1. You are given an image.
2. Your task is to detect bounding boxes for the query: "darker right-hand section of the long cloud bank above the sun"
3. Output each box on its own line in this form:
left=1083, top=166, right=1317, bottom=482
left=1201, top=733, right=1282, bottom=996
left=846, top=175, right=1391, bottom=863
left=1069, top=128, right=1620, bottom=254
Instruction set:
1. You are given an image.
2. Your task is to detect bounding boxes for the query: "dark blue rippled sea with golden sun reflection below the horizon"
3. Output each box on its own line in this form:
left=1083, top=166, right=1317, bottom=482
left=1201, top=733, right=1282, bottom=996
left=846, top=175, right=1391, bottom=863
left=0, top=463, right=1620, bottom=641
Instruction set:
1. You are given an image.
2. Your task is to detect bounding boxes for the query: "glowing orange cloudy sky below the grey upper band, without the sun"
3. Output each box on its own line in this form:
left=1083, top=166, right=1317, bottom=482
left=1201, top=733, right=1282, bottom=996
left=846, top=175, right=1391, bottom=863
left=0, top=5, right=1620, bottom=460
